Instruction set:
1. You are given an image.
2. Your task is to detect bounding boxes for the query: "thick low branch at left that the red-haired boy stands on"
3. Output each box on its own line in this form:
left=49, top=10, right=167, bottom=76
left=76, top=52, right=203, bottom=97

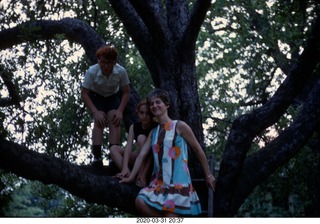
left=0, top=136, right=139, bottom=214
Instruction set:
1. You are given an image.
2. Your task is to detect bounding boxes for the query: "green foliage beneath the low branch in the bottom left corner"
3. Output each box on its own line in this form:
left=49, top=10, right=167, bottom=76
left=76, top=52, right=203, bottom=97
left=2, top=180, right=127, bottom=217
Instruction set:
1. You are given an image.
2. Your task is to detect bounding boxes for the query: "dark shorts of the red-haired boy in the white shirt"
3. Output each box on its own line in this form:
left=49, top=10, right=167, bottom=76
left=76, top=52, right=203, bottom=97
left=89, top=90, right=120, bottom=114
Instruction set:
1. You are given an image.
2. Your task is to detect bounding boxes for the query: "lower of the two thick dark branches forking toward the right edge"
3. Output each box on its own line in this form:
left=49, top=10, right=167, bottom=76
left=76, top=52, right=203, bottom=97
left=238, top=81, right=320, bottom=203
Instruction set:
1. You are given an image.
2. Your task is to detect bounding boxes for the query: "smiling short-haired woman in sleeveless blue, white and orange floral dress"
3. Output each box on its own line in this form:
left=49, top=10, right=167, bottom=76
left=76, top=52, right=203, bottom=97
left=120, top=89, right=215, bottom=217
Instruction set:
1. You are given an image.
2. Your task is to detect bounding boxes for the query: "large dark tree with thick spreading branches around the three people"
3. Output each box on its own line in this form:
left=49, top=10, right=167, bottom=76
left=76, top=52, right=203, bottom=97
left=0, top=0, right=320, bottom=216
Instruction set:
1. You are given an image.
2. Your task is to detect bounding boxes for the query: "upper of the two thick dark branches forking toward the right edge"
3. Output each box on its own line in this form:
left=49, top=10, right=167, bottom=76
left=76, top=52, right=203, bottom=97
left=239, top=16, right=320, bottom=135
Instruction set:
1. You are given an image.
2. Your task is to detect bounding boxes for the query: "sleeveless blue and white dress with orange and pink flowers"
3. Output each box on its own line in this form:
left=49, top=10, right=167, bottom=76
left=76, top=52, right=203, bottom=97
left=138, top=121, right=201, bottom=215
